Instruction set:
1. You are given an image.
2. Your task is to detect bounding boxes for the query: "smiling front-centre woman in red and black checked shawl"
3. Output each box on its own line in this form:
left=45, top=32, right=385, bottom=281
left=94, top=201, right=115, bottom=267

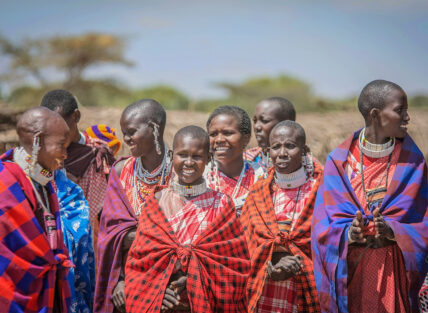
left=125, top=126, right=249, bottom=313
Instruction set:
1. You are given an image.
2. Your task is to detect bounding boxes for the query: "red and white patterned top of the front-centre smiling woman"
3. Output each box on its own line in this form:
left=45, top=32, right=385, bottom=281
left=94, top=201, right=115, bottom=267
left=159, top=188, right=230, bottom=245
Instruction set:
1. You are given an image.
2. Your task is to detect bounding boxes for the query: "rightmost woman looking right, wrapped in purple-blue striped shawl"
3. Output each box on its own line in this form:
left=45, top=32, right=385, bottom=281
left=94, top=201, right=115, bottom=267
left=312, top=80, right=428, bottom=313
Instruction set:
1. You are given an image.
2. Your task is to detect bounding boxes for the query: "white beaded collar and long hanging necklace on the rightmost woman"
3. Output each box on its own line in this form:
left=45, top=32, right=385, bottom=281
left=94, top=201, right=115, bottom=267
left=358, top=129, right=395, bottom=211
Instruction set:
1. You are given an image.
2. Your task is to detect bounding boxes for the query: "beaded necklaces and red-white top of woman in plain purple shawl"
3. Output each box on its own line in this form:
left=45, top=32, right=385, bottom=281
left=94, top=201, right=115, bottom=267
left=132, top=144, right=171, bottom=216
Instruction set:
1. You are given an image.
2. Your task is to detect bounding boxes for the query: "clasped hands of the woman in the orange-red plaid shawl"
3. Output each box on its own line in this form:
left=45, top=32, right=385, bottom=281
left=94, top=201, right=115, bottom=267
left=266, top=255, right=302, bottom=281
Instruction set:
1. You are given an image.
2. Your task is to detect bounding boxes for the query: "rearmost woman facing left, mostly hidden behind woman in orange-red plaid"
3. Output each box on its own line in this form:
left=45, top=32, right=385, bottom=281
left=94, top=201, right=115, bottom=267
left=244, top=97, right=296, bottom=176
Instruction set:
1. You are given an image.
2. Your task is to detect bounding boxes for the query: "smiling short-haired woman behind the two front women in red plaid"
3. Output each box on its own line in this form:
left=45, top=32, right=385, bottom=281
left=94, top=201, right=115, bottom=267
left=205, top=105, right=264, bottom=215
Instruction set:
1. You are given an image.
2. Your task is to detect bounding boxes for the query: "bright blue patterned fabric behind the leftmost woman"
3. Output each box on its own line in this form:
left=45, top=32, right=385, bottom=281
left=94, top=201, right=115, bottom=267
left=55, top=171, right=95, bottom=313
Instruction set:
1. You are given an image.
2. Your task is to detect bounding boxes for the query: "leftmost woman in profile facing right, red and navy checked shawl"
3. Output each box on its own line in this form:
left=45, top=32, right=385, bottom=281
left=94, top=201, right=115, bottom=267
left=0, top=107, right=72, bottom=312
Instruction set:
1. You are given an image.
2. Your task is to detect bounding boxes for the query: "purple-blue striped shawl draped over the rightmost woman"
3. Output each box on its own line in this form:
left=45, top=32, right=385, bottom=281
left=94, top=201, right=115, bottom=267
left=312, top=131, right=428, bottom=312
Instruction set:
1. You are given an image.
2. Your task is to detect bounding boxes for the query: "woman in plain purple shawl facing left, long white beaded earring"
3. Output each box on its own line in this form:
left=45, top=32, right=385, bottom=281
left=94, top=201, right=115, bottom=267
left=94, top=99, right=171, bottom=313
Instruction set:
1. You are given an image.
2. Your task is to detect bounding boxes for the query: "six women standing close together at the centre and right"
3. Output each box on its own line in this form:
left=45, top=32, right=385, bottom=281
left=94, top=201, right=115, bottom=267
left=94, top=80, right=428, bottom=313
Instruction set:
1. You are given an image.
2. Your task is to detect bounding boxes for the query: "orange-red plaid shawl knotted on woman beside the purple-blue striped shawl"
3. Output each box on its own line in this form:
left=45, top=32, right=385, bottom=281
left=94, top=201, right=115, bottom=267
left=241, top=162, right=323, bottom=312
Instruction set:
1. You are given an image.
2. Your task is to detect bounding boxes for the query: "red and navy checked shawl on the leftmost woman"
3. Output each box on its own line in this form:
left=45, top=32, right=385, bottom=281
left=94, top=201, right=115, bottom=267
left=0, top=150, right=73, bottom=313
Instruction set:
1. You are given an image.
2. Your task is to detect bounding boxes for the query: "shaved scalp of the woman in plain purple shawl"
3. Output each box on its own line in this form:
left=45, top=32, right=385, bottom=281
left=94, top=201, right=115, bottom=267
left=122, top=99, right=166, bottom=134
